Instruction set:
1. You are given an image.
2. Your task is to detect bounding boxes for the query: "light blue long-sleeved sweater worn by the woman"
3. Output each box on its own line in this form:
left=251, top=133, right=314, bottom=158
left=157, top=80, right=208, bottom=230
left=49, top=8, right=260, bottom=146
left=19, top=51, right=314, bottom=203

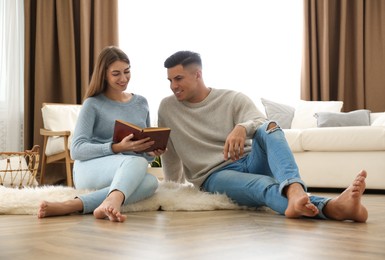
left=71, top=94, right=153, bottom=161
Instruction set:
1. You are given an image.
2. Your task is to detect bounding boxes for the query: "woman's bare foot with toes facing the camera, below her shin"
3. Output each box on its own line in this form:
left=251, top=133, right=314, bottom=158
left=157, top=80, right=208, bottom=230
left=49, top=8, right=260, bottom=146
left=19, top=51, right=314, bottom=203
left=94, top=191, right=126, bottom=222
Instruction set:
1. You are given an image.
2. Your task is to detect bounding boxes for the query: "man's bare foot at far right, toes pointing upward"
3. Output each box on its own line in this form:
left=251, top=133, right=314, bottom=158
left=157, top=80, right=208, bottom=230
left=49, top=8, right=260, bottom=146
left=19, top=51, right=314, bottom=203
left=323, top=170, right=368, bottom=222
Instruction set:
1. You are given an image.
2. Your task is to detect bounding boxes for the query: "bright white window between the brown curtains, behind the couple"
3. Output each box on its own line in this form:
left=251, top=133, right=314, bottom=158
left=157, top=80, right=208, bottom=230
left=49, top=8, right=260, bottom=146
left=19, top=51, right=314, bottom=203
left=119, top=0, right=303, bottom=124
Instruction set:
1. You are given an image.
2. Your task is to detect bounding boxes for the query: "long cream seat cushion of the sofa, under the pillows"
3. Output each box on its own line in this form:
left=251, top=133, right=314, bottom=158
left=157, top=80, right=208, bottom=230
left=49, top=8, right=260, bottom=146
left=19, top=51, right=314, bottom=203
left=301, top=126, right=385, bottom=152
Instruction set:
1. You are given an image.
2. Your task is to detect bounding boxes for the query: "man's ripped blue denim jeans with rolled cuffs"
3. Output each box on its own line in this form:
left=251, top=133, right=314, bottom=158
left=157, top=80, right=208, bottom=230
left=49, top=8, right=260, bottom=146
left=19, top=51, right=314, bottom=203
left=202, top=121, right=330, bottom=219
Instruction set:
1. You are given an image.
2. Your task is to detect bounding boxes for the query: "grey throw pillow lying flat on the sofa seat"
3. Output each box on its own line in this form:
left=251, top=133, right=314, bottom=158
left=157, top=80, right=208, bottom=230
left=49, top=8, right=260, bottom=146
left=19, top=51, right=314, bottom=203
left=314, top=109, right=370, bottom=127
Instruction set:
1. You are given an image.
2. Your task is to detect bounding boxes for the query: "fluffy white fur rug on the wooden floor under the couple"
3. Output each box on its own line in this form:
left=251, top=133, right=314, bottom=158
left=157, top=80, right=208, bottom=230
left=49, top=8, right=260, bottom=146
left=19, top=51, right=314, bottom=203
left=0, top=182, right=244, bottom=215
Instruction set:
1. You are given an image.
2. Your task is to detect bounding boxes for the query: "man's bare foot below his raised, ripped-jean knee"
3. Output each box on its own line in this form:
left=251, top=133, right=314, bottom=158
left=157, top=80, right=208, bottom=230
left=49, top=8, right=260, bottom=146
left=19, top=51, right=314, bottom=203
left=285, top=183, right=319, bottom=218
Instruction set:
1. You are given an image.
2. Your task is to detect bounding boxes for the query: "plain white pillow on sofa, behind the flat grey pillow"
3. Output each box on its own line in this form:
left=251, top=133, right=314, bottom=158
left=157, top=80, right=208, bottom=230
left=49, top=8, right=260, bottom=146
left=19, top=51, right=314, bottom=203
left=291, top=100, right=343, bottom=129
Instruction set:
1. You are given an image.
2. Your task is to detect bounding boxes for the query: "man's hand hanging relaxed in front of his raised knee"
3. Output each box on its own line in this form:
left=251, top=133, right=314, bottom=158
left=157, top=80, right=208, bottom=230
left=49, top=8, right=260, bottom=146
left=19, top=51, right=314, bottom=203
left=223, top=125, right=246, bottom=161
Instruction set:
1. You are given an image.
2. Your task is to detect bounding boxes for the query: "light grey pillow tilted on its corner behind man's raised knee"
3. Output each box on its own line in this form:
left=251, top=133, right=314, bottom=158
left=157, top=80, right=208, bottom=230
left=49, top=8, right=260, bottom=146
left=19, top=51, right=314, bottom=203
left=261, top=98, right=295, bottom=129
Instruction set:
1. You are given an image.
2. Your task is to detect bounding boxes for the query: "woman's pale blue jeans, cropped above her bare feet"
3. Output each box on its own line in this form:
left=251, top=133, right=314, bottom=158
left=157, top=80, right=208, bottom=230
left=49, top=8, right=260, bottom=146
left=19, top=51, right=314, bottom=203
left=74, top=154, right=158, bottom=214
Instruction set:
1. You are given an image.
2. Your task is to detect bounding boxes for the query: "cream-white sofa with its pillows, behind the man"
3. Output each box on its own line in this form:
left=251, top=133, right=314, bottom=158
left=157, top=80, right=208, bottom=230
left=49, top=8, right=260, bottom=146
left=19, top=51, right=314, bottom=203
left=262, top=99, right=385, bottom=190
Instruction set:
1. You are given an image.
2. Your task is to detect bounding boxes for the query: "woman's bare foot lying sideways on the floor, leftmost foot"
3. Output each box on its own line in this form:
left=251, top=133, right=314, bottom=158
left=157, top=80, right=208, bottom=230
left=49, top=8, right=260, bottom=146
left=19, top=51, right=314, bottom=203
left=37, top=199, right=83, bottom=218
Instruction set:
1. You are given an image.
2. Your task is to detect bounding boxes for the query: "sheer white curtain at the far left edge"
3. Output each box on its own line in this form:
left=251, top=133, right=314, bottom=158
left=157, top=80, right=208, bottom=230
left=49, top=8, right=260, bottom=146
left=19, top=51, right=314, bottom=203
left=0, top=0, right=24, bottom=151
